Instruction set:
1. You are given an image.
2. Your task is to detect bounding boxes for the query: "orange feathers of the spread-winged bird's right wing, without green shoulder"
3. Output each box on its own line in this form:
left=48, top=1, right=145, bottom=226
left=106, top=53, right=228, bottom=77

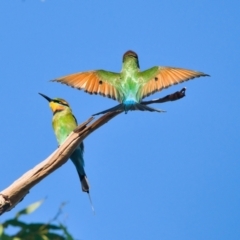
left=141, top=67, right=209, bottom=98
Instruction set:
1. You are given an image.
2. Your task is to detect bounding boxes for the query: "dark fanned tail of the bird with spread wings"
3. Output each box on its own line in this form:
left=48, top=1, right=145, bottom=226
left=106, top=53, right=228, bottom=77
left=92, top=103, right=165, bottom=116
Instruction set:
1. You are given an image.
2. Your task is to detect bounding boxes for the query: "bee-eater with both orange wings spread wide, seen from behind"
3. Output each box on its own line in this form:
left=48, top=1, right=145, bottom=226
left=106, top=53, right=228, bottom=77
left=52, top=51, right=209, bottom=115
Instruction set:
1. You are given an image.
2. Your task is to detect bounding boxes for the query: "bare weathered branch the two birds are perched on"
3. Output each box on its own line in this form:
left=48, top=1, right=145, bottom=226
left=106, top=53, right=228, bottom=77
left=0, top=88, right=186, bottom=215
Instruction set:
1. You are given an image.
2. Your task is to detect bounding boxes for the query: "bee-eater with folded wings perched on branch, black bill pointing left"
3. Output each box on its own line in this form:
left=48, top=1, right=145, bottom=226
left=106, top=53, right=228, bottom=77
left=39, top=93, right=90, bottom=194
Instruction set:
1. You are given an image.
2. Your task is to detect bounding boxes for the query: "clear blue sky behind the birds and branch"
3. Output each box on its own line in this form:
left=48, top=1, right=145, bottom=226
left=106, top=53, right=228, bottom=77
left=0, top=0, right=240, bottom=240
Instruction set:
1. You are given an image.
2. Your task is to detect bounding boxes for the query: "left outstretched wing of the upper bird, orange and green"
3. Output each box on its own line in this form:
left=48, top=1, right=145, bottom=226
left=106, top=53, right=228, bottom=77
left=51, top=70, right=120, bottom=101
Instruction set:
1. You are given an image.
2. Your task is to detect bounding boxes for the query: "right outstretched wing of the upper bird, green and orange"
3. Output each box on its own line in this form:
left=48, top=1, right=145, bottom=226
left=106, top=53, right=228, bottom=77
left=138, top=67, right=209, bottom=98
